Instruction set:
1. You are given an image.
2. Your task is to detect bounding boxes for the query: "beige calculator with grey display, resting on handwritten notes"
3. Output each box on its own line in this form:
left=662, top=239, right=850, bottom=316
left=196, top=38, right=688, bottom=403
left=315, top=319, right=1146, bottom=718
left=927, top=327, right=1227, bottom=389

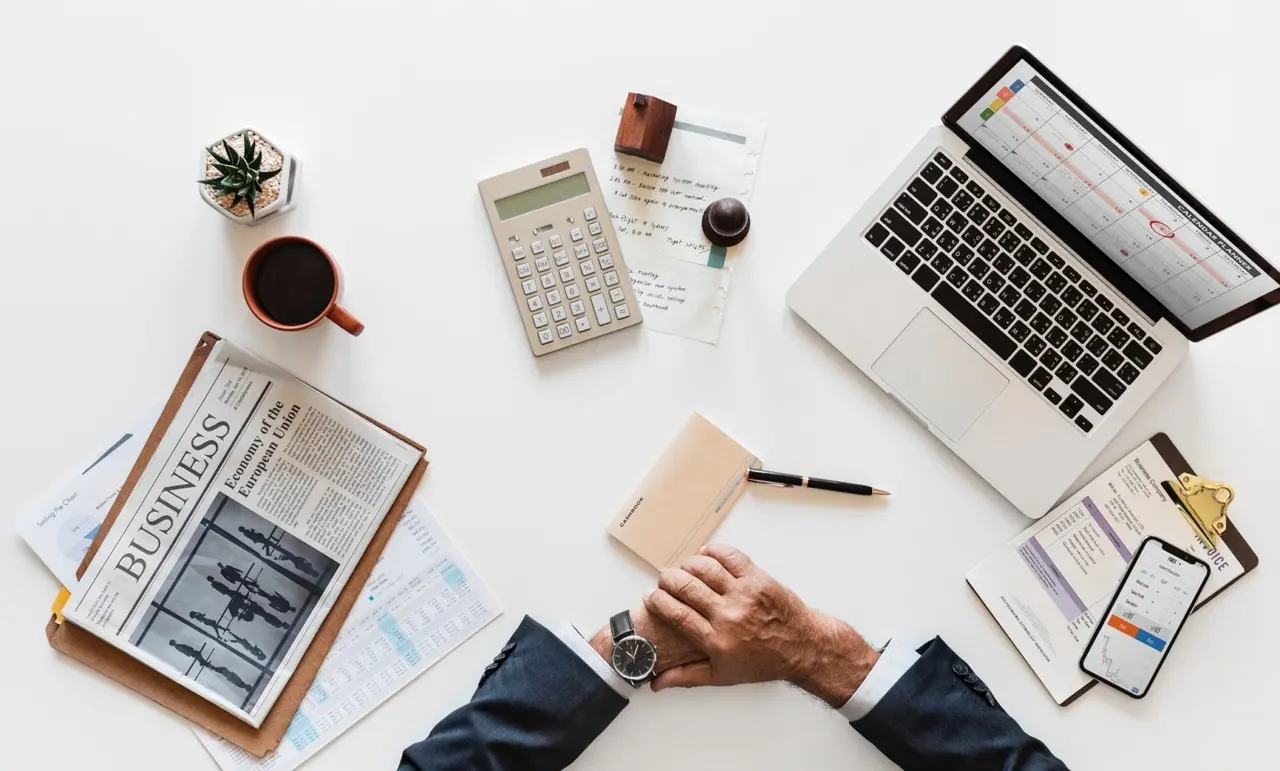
left=480, top=149, right=641, bottom=356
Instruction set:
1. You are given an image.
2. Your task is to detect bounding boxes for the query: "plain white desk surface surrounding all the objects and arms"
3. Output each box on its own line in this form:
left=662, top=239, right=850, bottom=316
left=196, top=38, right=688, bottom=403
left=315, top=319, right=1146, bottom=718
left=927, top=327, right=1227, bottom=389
left=0, top=0, right=1280, bottom=771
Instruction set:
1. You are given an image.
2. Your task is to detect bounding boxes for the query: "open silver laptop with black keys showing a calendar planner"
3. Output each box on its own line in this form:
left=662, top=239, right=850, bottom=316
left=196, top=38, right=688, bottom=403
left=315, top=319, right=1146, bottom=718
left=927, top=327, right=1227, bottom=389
left=787, top=46, right=1280, bottom=517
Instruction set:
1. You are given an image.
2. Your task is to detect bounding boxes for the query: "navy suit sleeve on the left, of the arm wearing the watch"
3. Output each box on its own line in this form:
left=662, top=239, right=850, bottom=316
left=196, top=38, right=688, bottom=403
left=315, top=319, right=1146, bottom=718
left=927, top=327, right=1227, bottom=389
left=399, top=616, right=627, bottom=771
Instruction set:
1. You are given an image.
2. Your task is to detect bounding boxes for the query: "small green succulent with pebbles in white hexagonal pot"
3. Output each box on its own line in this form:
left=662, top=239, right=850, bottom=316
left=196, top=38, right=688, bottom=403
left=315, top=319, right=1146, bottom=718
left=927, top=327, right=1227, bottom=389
left=198, top=128, right=298, bottom=225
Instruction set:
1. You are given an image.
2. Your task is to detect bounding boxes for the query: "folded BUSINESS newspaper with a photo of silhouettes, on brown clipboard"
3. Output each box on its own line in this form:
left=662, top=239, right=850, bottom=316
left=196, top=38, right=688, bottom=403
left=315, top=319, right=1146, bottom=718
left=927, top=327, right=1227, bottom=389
left=63, top=341, right=422, bottom=727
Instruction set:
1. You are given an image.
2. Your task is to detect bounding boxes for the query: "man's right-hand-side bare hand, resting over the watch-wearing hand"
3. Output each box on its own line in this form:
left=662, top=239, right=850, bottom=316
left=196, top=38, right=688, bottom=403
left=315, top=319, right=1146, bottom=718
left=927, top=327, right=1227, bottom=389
left=644, top=544, right=879, bottom=707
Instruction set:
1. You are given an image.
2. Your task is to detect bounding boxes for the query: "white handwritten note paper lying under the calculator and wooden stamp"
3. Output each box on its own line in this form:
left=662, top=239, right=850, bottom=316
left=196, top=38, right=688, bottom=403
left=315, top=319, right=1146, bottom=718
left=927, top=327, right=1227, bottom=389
left=595, top=101, right=764, bottom=343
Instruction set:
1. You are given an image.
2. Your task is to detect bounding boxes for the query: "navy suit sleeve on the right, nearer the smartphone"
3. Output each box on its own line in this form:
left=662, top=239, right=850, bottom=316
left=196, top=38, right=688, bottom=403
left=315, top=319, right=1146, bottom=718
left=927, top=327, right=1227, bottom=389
left=852, top=638, right=1066, bottom=771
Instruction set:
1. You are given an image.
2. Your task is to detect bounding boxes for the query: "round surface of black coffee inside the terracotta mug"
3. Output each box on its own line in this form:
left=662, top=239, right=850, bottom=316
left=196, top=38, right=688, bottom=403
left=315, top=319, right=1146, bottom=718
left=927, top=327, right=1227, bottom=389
left=253, top=241, right=337, bottom=327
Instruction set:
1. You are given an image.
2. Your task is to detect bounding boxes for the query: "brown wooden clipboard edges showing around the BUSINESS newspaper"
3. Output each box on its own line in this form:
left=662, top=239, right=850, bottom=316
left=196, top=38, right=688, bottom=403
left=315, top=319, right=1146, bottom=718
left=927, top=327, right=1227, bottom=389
left=45, top=332, right=428, bottom=757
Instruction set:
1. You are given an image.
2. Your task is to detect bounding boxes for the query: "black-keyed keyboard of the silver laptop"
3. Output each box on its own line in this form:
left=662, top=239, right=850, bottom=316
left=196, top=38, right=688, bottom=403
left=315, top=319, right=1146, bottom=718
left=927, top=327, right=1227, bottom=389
left=863, top=150, right=1161, bottom=433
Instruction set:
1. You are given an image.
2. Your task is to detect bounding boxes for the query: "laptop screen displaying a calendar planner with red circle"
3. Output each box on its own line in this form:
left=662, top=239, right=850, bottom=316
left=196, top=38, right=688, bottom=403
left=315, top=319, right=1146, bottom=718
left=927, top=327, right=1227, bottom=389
left=956, top=59, right=1280, bottom=330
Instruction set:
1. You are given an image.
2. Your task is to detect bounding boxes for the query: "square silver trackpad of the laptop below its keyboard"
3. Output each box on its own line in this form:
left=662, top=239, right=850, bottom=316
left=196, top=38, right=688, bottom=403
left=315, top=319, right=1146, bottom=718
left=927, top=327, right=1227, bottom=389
left=872, top=309, right=1009, bottom=442
